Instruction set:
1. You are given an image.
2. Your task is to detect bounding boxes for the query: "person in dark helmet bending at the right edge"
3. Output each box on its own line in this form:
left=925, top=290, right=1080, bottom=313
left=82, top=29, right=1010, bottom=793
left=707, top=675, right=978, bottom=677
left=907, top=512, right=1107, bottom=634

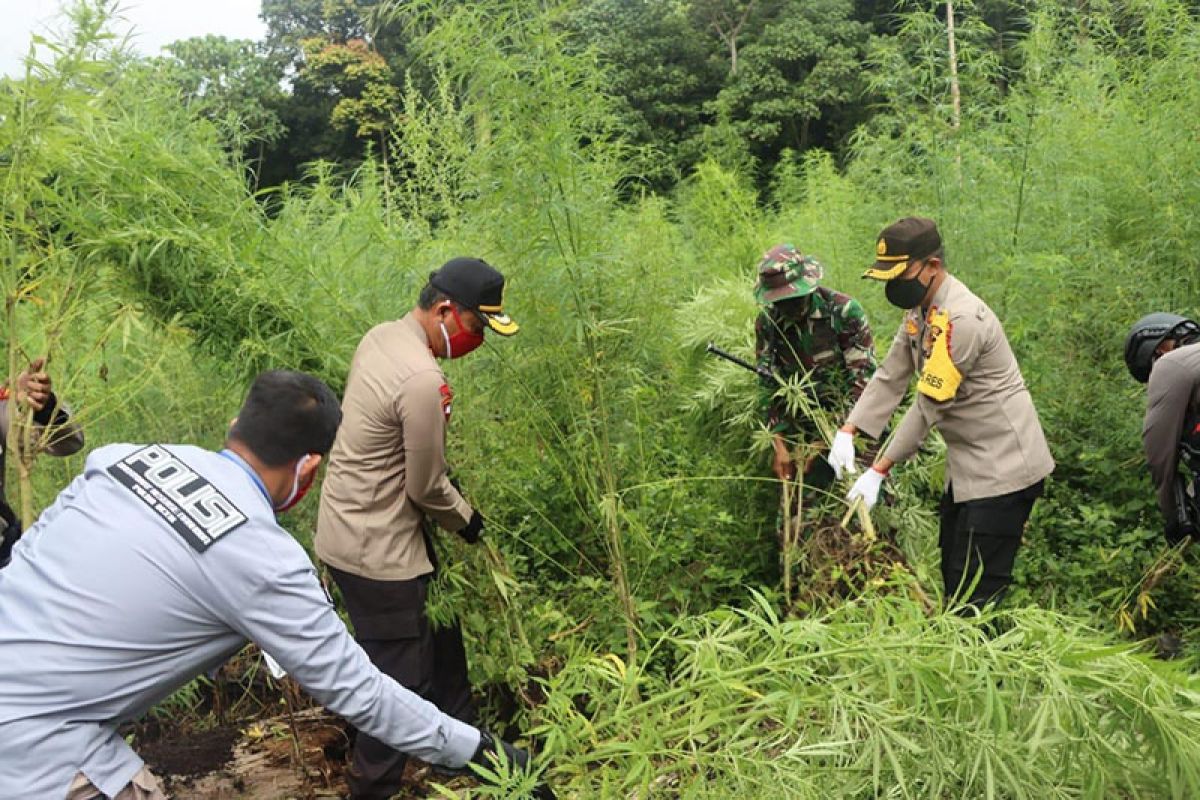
left=1124, top=312, right=1200, bottom=545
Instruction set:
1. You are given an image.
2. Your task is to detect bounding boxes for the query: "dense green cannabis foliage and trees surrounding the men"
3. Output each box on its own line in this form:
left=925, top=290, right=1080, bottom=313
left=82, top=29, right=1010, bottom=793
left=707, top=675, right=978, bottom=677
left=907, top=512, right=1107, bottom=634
left=0, top=0, right=1200, bottom=798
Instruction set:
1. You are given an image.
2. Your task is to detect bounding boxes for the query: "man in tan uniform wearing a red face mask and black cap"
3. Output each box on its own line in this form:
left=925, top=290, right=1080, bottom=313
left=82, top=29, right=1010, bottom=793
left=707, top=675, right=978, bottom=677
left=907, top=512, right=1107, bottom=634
left=314, top=258, right=517, bottom=800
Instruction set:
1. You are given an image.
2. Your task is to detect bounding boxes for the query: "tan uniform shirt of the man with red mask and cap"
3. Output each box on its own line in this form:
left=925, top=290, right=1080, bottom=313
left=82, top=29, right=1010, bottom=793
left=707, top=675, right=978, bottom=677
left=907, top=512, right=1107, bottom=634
left=313, top=313, right=472, bottom=581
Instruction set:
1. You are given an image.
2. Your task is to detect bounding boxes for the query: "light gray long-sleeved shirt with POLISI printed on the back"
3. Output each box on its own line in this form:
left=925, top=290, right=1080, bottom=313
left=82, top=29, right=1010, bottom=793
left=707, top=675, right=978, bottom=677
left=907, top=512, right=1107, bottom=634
left=0, top=445, right=479, bottom=800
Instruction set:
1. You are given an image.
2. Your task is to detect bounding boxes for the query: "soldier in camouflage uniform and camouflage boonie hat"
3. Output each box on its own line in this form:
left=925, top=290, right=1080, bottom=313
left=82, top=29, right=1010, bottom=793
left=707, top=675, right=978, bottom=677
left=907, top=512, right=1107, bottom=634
left=755, top=245, right=875, bottom=488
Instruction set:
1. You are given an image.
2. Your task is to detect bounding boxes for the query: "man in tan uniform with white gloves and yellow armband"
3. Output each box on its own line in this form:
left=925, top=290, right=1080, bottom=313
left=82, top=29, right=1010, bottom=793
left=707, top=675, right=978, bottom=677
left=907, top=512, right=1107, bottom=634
left=829, top=217, right=1054, bottom=607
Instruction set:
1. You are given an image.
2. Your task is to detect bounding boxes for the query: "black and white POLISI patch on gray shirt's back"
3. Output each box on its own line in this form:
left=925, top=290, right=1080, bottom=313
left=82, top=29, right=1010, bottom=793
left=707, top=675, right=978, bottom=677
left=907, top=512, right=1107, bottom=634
left=108, top=445, right=247, bottom=553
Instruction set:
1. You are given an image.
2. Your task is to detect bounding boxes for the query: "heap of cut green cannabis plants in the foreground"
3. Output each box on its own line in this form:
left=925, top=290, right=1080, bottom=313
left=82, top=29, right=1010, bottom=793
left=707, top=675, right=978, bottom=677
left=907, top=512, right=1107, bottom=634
left=530, top=596, right=1200, bottom=799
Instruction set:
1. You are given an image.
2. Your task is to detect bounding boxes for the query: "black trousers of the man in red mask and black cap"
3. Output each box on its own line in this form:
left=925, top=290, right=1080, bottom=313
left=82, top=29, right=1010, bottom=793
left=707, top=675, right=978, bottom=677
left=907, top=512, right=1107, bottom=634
left=329, top=567, right=475, bottom=800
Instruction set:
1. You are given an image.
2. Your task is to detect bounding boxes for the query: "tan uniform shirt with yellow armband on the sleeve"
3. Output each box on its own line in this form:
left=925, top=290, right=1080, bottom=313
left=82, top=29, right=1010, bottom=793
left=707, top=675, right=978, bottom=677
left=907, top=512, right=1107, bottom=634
left=848, top=275, right=1054, bottom=503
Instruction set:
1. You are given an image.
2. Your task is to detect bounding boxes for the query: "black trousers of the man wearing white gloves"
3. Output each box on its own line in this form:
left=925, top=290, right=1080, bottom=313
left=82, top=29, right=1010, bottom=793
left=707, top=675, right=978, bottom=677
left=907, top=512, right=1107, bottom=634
left=938, top=481, right=1044, bottom=608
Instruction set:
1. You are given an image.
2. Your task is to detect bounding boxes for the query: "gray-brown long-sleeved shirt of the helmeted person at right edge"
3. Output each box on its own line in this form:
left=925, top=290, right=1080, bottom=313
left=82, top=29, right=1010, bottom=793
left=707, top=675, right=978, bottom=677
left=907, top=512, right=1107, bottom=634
left=1141, top=344, right=1200, bottom=519
